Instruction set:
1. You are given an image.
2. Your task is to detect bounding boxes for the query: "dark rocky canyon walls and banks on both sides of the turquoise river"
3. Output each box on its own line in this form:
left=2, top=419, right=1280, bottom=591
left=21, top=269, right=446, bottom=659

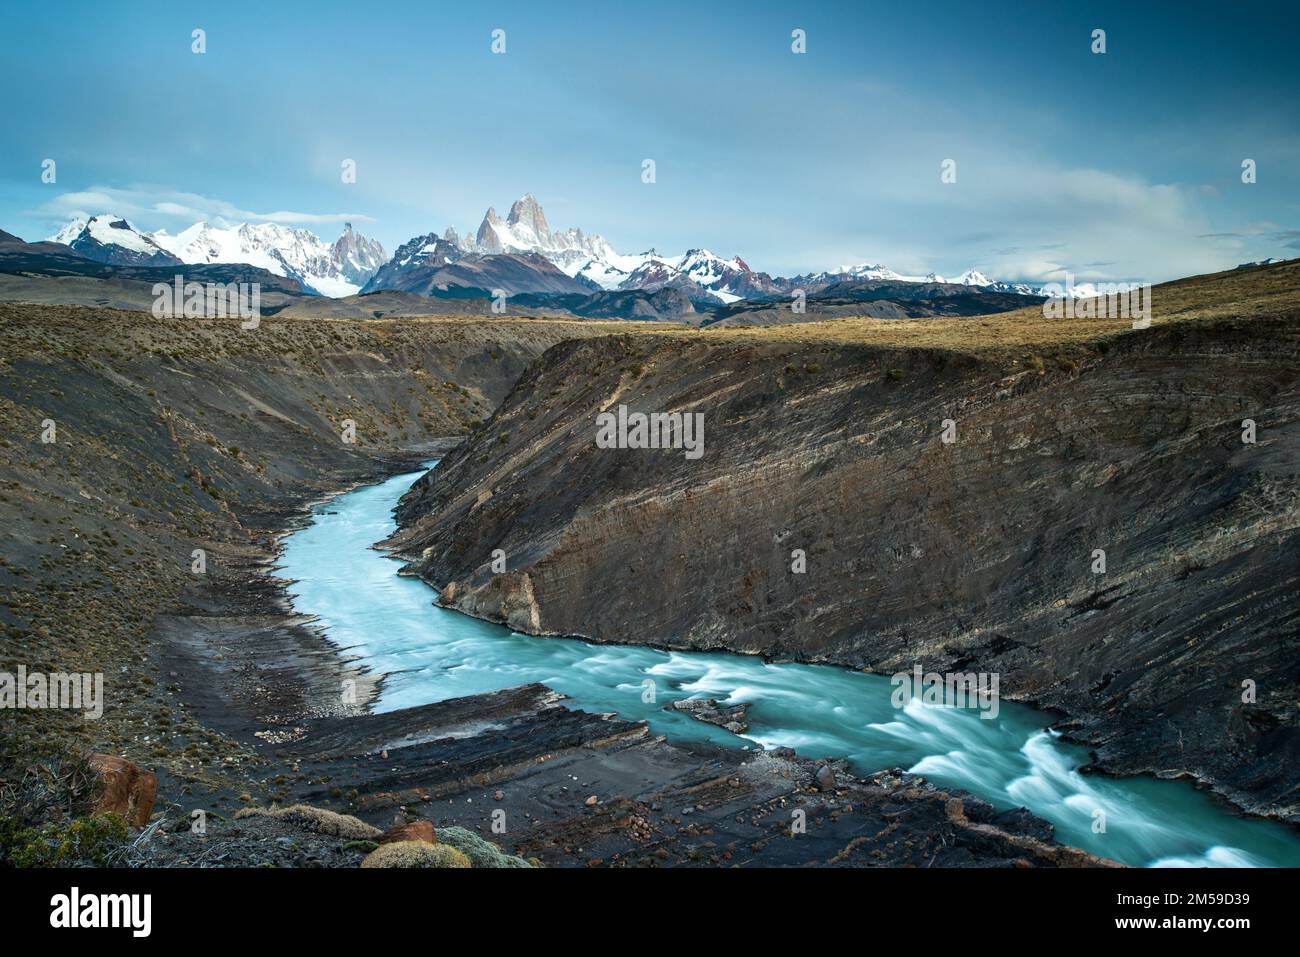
left=0, top=254, right=1300, bottom=866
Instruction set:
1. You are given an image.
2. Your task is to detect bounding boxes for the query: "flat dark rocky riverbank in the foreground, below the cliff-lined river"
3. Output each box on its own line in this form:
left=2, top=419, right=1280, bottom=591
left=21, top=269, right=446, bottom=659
left=139, top=460, right=1106, bottom=866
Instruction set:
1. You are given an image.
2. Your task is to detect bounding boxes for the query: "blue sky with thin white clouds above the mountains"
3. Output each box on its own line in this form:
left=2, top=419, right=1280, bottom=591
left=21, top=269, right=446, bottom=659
left=0, top=0, right=1300, bottom=282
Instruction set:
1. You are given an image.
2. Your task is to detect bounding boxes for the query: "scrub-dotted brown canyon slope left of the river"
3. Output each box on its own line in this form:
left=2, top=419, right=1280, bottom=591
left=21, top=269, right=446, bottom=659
left=0, top=304, right=616, bottom=767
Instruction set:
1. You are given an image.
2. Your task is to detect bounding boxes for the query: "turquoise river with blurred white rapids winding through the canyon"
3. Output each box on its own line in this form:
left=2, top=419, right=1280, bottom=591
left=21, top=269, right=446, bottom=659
left=282, top=462, right=1300, bottom=867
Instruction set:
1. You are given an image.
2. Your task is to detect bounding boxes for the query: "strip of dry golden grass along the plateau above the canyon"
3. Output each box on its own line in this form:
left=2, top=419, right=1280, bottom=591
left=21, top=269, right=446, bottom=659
left=0, top=260, right=1300, bottom=358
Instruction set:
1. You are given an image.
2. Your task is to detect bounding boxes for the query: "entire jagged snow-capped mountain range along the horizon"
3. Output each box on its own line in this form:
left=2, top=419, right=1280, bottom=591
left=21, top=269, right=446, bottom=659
left=49, top=194, right=1043, bottom=312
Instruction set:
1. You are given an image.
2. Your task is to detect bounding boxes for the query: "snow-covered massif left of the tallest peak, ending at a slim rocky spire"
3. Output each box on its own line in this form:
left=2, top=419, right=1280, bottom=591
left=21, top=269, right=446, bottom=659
left=49, top=216, right=386, bottom=296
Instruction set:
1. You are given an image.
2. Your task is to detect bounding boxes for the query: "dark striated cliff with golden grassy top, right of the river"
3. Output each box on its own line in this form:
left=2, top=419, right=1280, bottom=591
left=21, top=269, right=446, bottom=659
left=394, top=264, right=1300, bottom=819
